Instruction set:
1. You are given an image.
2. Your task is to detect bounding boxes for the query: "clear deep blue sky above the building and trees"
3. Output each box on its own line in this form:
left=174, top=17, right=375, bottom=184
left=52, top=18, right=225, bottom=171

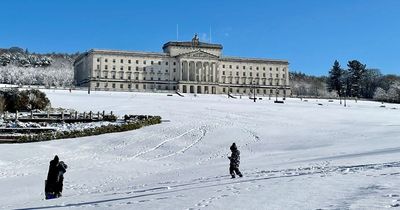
left=0, top=0, right=400, bottom=75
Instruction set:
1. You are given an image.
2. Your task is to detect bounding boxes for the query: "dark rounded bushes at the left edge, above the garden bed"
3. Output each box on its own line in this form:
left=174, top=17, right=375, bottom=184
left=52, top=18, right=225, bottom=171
left=0, top=89, right=50, bottom=112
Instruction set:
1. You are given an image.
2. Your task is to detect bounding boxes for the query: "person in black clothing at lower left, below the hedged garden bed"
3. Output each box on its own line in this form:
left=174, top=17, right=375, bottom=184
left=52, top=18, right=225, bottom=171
left=45, top=155, right=67, bottom=199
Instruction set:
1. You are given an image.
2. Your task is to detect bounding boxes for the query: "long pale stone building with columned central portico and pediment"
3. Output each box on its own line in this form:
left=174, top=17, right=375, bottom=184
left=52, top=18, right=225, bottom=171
left=74, top=35, right=290, bottom=95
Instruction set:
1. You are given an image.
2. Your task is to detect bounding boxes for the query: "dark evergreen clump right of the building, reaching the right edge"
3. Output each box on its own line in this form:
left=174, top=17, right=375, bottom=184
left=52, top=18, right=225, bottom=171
left=327, top=60, right=400, bottom=103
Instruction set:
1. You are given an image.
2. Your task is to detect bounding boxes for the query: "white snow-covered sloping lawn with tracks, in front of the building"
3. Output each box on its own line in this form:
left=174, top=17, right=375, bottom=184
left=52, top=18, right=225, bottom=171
left=0, top=91, right=400, bottom=209
